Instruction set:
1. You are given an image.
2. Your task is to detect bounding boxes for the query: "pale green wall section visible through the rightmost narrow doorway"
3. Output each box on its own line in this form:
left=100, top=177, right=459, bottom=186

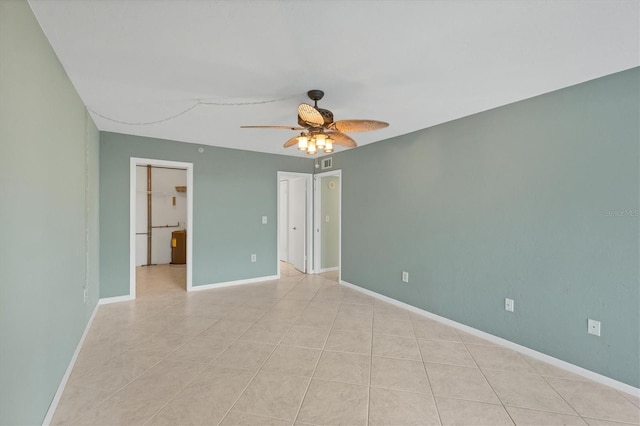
left=320, top=176, right=340, bottom=269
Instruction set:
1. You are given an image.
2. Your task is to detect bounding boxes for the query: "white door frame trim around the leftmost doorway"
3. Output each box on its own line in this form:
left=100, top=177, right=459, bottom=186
left=129, top=157, right=193, bottom=299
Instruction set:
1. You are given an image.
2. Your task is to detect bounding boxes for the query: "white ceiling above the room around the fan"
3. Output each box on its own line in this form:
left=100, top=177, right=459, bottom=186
left=29, top=0, right=640, bottom=155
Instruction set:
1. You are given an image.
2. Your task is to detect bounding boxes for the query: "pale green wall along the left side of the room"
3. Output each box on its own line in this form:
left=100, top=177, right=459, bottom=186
left=0, top=0, right=99, bottom=425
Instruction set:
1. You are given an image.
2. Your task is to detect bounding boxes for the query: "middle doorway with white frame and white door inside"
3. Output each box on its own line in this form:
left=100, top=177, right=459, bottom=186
left=277, top=172, right=313, bottom=276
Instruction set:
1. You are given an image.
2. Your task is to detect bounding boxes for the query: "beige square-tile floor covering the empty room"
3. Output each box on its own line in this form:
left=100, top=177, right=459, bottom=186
left=53, top=265, right=640, bottom=426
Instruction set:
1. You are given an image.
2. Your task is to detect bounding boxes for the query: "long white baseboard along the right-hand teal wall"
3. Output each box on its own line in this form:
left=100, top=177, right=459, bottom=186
left=340, top=280, right=640, bottom=397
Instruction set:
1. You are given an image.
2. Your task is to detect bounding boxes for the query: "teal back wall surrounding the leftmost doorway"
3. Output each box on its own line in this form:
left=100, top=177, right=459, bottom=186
left=100, top=132, right=313, bottom=297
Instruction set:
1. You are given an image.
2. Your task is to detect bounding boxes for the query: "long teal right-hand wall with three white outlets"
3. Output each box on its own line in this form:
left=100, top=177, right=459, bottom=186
left=333, top=68, right=640, bottom=387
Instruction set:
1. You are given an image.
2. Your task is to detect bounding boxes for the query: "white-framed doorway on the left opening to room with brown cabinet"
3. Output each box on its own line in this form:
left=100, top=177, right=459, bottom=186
left=129, top=158, right=193, bottom=299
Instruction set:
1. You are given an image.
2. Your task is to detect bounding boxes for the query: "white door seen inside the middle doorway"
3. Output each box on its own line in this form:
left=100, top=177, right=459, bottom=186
left=288, top=178, right=307, bottom=273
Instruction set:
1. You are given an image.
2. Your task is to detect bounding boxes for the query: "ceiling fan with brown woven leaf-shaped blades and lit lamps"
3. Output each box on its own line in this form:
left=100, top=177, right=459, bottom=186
left=240, top=90, right=389, bottom=155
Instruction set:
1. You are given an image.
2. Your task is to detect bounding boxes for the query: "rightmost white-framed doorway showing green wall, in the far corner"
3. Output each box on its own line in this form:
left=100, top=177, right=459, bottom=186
left=313, top=170, right=342, bottom=279
